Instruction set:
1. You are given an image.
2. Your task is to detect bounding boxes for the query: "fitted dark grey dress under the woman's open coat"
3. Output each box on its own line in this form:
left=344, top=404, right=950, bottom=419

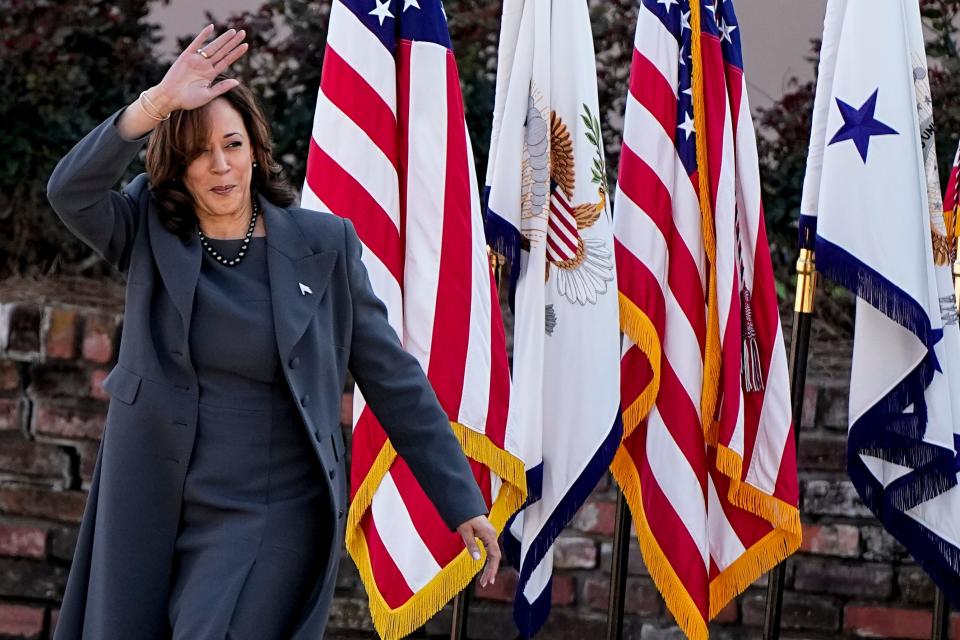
left=168, top=237, right=332, bottom=640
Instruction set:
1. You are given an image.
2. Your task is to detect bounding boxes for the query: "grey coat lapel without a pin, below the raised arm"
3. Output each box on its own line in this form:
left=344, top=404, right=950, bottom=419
left=147, top=200, right=202, bottom=335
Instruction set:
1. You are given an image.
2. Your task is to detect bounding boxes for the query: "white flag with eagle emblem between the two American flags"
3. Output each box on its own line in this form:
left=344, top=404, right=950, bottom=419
left=487, top=0, right=621, bottom=636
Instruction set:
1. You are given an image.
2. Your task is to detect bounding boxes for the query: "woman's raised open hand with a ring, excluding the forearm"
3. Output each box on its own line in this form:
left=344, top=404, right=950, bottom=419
left=156, top=24, right=249, bottom=115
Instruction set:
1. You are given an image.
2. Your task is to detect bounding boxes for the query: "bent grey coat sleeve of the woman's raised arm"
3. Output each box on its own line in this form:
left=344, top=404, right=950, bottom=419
left=47, top=113, right=147, bottom=271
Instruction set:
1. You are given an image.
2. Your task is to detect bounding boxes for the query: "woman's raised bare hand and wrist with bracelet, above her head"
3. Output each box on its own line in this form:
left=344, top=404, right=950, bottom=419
left=117, top=24, right=249, bottom=140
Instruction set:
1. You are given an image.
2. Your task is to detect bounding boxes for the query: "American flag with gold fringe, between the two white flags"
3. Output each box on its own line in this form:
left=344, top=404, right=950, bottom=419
left=612, top=0, right=800, bottom=638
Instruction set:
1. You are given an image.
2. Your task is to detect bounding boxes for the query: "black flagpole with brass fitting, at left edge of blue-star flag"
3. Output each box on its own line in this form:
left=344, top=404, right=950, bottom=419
left=763, top=241, right=817, bottom=640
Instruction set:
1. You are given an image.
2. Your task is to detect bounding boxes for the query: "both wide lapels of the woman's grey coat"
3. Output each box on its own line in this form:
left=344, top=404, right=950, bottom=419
left=148, top=195, right=337, bottom=361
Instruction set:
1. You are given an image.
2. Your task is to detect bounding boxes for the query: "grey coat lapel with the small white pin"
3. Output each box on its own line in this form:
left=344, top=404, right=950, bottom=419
left=260, top=198, right=337, bottom=361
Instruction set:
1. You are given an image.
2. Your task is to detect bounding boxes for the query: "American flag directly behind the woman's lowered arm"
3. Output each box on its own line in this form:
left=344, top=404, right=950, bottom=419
left=303, top=0, right=525, bottom=638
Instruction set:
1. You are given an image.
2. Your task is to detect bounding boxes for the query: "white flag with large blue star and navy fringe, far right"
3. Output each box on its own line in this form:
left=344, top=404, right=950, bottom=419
left=800, top=0, right=960, bottom=607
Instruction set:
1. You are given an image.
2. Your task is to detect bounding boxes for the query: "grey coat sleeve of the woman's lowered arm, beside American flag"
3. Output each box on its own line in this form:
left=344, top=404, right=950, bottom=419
left=343, top=220, right=487, bottom=530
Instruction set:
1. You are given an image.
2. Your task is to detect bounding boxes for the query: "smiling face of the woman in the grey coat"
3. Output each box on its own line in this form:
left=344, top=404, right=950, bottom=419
left=183, top=98, right=253, bottom=221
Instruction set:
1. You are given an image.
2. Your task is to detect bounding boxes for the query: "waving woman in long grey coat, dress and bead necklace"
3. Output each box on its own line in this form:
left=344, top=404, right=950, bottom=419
left=48, top=25, right=500, bottom=640
